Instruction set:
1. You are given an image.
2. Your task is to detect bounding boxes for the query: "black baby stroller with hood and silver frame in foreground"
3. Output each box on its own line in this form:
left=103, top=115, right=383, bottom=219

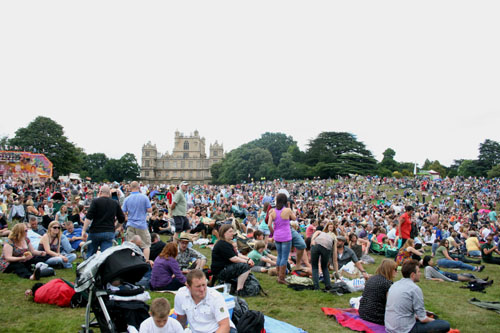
left=75, top=242, right=150, bottom=332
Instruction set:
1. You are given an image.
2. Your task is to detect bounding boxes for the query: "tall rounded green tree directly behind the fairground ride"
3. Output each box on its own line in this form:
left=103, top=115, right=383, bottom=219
left=9, top=116, right=83, bottom=177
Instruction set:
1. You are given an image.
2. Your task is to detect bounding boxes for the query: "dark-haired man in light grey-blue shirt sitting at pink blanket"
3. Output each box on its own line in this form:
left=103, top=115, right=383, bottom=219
left=385, top=260, right=450, bottom=333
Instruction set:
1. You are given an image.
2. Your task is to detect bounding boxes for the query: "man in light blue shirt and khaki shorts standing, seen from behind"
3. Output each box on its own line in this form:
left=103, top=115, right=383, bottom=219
left=122, top=181, right=153, bottom=261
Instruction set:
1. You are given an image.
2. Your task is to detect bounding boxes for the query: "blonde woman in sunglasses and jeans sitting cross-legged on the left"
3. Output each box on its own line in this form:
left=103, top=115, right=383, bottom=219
left=38, top=221, right=76, bottom=268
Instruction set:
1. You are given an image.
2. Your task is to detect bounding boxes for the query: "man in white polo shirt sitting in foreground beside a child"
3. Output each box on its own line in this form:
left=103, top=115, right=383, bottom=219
left=174, top=269, right=236, bottom=333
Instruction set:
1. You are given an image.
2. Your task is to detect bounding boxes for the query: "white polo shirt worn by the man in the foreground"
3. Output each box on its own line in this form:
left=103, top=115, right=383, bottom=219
left=174, top=287, right=235, bottom=333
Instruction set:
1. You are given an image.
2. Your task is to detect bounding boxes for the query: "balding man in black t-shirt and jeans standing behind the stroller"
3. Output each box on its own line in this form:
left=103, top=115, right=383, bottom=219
left=82, top=185, right=125, bottom=257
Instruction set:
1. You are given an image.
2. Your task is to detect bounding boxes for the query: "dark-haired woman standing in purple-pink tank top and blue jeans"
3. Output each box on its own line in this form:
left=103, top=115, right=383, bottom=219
left=269, top=193, right=297, bottom=284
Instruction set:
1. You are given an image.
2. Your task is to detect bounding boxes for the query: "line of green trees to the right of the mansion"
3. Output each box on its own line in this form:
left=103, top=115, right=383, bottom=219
left=211, top=132, right=500, bottom=184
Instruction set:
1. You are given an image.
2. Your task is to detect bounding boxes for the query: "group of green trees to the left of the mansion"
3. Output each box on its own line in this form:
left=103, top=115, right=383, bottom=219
left=0, top=116, right=140, bottom=182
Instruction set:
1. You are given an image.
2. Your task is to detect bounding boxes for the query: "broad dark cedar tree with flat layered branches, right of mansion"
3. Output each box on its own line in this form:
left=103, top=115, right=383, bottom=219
left=306, top=132, right=377, bottom=178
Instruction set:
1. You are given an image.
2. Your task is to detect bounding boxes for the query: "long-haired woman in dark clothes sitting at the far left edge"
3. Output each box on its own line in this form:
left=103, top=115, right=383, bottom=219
left=0, top=223, right=46, bottom=280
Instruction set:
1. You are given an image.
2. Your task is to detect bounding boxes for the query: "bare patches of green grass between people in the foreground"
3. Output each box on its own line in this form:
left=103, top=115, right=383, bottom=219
left=0, top=239, right=500, bottom=332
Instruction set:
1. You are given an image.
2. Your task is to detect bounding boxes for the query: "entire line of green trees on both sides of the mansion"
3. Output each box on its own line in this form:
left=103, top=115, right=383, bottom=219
left=0, top=116, right=500, bottom=184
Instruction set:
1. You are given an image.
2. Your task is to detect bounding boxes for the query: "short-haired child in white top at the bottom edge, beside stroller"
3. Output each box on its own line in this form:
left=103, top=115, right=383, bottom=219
left=139, top=297, right=184, bottom=333
